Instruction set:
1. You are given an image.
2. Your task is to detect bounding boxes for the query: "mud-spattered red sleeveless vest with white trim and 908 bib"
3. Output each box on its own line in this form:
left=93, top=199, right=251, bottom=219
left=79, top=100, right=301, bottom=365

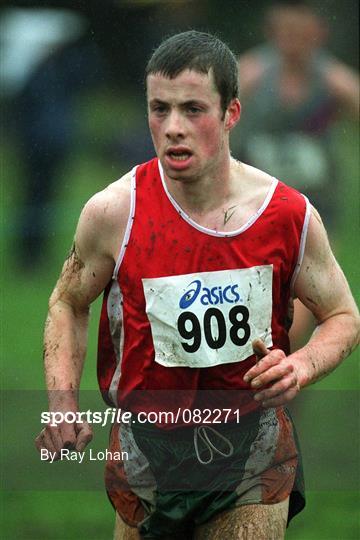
left=98, top=159, right=310, bottom=420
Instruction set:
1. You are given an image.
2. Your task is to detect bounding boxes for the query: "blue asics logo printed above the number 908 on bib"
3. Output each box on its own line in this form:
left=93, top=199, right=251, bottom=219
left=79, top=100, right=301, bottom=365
left=179, top=279, right=241, bottom=309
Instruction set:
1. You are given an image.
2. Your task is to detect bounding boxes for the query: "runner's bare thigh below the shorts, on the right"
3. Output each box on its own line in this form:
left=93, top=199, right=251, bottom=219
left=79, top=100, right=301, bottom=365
left=194, top=498, right=289, bottom=540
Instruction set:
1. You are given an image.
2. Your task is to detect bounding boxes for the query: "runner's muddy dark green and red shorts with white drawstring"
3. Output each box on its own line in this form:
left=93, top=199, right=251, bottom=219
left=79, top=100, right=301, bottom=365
left=105, top=409, right=305, bottom=539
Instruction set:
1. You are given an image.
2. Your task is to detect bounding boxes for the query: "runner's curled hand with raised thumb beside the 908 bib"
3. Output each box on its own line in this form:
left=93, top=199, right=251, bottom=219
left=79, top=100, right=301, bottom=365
left=244, top=339, right=300, bottom=408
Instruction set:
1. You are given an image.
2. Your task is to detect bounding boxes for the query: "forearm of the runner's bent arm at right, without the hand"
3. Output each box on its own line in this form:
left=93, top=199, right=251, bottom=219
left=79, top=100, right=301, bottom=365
left=291, top=314, right=359, bottom=387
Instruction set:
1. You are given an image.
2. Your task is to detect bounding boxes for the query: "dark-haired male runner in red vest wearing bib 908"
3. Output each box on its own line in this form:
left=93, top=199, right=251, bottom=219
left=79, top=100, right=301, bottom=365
left=37, top=31, right=359, bottom=540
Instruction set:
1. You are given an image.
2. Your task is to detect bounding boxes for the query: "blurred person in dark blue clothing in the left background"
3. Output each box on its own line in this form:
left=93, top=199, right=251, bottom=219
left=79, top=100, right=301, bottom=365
left=13, top=38, right=105, bottom=272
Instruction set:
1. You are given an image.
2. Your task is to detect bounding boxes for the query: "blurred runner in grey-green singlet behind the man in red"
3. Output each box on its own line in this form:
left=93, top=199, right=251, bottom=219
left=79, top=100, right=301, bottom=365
left=233, top=2, right=359, bottom=347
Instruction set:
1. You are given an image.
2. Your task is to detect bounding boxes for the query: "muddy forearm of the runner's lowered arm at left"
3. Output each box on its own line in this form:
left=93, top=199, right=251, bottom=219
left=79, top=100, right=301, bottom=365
left=44, top=301, right=88, bottom=410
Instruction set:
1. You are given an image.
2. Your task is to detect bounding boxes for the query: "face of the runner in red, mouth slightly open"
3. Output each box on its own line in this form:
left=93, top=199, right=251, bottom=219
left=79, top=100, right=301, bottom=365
left=147, top=70, right=236, bottom=180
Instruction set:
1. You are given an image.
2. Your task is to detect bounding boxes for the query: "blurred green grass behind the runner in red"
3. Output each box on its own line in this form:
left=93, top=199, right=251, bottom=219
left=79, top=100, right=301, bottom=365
left=0, top=115, right=360, bottom=540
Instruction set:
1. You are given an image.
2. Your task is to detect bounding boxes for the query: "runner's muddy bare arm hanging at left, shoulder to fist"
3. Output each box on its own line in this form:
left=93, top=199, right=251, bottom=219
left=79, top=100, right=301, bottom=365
left=36, top=176, right=128, bottom=452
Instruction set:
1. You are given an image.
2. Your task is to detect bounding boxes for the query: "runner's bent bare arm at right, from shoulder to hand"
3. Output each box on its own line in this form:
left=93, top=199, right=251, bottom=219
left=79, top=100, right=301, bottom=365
left=245, top=209, right=360, bottom=407
